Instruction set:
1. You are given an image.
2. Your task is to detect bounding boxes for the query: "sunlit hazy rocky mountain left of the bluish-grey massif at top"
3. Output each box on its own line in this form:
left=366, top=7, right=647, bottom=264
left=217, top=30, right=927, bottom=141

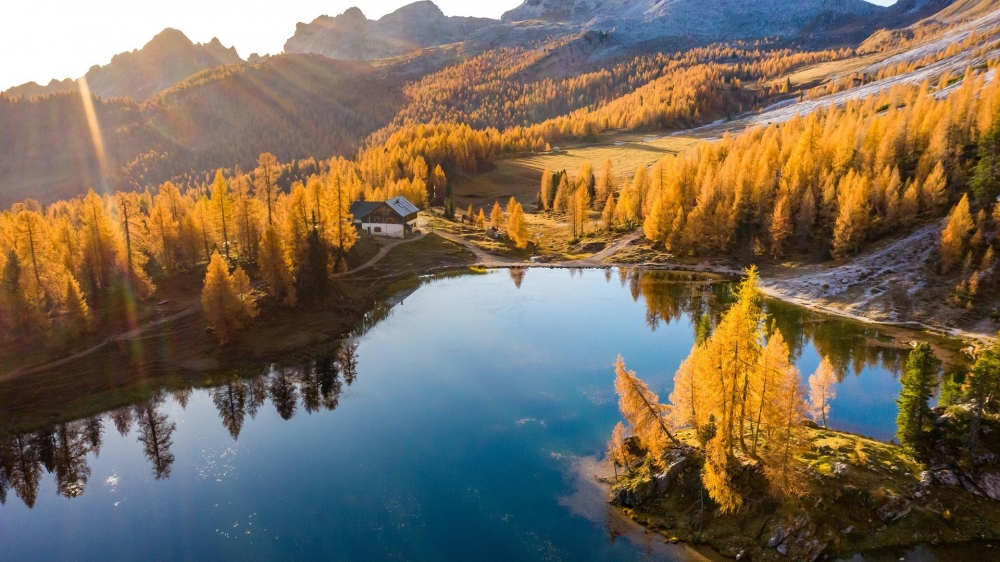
left=285, top=0, right=499, bottom=60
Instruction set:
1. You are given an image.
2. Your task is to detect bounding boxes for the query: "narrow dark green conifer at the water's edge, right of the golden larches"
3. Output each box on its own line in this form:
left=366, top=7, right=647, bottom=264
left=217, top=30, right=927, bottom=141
left=896, top=343, right=937, bottom=450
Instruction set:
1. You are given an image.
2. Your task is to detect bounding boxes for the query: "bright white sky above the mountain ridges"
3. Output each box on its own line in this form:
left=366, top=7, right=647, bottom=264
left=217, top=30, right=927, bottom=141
left=0, top=0, right=895, bottom=90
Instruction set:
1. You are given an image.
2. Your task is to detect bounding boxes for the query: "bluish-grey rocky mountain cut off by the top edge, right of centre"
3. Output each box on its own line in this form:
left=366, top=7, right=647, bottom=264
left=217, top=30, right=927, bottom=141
left=502, top=0, right=885, bottom=41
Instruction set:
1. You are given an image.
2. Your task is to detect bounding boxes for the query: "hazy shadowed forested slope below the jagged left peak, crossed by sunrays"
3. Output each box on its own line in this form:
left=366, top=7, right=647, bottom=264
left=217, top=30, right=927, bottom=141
left=0, top=54, right=405, bottom=208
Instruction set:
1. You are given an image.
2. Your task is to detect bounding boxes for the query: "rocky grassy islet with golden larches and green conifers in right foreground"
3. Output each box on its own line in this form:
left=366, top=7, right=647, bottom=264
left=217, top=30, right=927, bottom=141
left=607, top=268, right=1000, bottom=561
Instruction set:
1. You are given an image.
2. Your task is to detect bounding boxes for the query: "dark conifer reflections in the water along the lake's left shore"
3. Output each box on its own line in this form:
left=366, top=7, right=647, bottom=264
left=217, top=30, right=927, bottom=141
left=0, top=344, right=358, bottom=508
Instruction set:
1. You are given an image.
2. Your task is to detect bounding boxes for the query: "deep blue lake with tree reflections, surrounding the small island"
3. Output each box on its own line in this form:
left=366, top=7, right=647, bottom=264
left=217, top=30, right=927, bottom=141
left=0, top=269, right=968, bottom=562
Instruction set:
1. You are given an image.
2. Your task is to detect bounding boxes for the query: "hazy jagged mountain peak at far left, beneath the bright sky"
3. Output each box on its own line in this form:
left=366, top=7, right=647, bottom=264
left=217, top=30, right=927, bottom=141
left=4, top=28, right=242, bottom=102
